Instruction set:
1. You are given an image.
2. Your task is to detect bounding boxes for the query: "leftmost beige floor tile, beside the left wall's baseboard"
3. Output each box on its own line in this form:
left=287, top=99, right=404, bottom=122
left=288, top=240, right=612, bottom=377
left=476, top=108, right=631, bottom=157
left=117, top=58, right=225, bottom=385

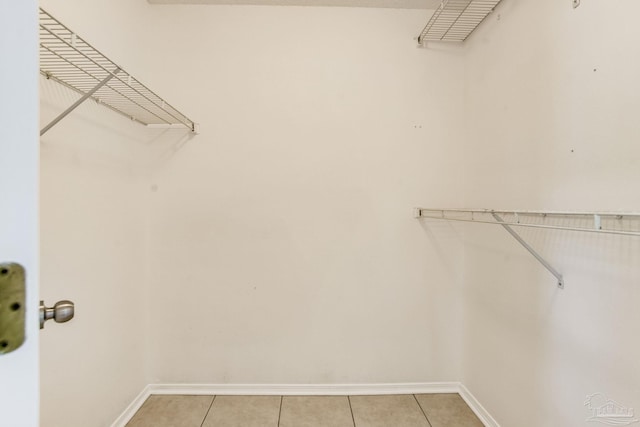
left=127, top=395, right=213, bottom=427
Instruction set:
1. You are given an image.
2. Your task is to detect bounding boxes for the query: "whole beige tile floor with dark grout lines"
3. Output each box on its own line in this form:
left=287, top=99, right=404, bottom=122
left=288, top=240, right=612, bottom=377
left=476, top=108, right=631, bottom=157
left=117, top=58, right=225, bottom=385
left=127, top=393, right=483, bottom=427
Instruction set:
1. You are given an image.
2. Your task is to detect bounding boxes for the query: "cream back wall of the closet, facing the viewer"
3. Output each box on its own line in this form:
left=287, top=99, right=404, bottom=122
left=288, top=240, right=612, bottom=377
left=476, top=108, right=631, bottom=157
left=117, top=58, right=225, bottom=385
left=145, top=6, right=463, bottom=384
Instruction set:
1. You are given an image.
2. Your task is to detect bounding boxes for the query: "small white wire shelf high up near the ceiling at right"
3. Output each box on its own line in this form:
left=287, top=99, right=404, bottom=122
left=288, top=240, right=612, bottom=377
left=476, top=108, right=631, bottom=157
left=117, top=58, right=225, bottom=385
left=418, top=0, right=500, bottom=44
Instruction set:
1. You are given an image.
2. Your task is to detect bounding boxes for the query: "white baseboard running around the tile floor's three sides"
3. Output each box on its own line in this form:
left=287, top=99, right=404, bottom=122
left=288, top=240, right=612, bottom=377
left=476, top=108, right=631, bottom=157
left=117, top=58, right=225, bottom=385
left=111, top=382, right=500, bottom=427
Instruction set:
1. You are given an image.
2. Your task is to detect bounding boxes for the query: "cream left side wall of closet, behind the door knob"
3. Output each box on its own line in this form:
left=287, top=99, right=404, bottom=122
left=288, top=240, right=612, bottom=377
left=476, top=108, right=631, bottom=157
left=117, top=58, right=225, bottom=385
left=40, top=2, right=158, bottom=427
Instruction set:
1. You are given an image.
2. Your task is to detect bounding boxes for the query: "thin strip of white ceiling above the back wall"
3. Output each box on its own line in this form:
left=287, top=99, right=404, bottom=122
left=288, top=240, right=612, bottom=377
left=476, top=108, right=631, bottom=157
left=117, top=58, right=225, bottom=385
left=148, top=0, right=440, bottom=9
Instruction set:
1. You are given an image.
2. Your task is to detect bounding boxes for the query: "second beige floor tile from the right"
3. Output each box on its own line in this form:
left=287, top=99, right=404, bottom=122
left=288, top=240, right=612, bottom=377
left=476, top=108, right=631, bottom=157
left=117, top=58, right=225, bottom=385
left=350, top=394, right=429, bottom=427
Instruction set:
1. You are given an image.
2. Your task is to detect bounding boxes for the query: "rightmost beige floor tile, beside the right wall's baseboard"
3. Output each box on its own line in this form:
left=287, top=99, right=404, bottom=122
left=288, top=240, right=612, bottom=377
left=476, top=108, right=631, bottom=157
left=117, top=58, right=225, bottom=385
left=416, top=393, right=484, bottom=427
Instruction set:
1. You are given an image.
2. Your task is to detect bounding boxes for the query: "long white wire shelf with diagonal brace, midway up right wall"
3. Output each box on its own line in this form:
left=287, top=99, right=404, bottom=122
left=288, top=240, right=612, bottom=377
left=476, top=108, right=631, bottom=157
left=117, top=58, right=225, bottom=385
left=414, top=208, right=640, bottom=288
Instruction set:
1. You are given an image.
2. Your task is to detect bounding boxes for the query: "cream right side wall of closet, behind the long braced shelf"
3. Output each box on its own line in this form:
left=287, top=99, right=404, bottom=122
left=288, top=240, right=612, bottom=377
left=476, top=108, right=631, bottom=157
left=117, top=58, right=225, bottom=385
left=463, top=0, right=640, bottom=427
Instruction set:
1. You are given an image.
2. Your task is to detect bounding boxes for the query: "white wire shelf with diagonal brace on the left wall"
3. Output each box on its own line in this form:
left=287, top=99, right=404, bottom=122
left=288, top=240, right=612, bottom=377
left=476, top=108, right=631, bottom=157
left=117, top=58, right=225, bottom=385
left=39, top=8, right=196, bottom=135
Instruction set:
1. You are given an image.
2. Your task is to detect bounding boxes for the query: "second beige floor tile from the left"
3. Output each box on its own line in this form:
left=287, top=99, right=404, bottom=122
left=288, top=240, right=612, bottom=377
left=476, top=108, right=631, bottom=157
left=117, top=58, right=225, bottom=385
left=202, top=396, right=281, bottom=427
